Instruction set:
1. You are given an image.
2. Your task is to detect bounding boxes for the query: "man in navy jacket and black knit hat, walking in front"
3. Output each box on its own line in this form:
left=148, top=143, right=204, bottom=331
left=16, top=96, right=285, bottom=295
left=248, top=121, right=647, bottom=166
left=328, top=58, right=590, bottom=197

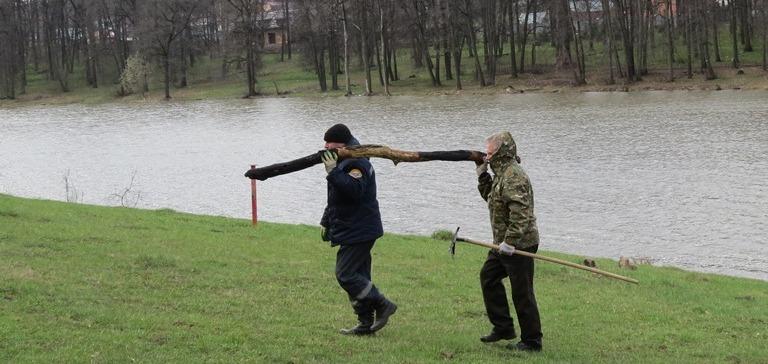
left=320, top=124, right=397, bottom=335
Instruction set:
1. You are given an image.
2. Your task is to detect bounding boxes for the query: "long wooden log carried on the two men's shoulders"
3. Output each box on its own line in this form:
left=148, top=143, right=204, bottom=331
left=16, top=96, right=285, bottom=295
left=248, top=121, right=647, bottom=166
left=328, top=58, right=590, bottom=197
left=245, top=144, right=485, bottom=181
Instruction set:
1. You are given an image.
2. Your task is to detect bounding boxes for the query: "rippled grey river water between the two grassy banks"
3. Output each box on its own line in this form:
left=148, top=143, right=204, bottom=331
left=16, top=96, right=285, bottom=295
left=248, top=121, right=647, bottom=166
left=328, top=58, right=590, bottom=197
left=0, top=91, right=768, bottom=280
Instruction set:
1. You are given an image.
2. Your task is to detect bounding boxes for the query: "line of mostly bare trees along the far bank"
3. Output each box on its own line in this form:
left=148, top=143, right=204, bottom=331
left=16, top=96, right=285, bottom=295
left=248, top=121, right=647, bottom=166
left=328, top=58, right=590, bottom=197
left=0, top=0, right=768, bottom=98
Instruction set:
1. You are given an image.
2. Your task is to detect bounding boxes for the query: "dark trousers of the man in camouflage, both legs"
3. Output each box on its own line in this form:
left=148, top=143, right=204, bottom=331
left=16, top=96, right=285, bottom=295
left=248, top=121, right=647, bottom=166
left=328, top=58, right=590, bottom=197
left=480, top=245, right=542, bottom=346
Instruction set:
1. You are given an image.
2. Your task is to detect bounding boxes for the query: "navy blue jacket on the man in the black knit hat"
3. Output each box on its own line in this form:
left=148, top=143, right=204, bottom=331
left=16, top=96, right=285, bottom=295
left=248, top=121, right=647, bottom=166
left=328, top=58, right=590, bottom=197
left=320, top=149, right=384, bottom=245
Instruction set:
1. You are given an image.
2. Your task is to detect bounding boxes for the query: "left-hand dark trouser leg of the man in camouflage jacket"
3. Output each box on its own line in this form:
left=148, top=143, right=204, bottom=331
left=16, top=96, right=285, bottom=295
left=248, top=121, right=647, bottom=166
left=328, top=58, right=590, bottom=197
left=480, top=251, right=515, bottom=333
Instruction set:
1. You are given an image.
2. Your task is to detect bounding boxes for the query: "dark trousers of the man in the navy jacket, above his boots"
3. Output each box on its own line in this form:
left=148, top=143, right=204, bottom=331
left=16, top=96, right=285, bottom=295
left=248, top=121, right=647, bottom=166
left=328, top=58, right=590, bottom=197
left=336, top=240, right=380, bottom=302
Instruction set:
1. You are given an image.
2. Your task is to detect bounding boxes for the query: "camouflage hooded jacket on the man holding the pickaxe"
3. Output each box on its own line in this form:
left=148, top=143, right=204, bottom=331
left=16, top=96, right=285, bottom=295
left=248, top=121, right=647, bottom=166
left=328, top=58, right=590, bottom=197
left=477, top=132, right=539, bottom=249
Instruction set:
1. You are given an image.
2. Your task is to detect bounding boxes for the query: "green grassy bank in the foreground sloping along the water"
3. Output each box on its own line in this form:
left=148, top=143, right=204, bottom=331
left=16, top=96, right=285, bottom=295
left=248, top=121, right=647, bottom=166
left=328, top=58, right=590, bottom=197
left=0, top=195, right=768, bottom=363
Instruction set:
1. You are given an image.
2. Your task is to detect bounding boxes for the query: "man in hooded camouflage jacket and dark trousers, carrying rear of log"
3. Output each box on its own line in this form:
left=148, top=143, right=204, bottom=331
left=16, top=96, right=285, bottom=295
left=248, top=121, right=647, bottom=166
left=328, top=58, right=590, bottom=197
left=477, top=132, right=542, bottom=351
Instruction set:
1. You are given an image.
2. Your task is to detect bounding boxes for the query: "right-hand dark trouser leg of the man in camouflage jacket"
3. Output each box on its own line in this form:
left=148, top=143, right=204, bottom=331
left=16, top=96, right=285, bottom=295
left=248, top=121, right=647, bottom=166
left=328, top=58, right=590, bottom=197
left=504, top=245, right=542, bottom=346
